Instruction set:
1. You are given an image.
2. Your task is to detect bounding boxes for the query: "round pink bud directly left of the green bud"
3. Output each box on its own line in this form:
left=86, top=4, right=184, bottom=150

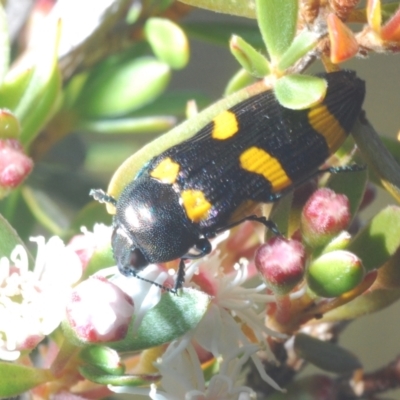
left=255, top=237, right=305, bottom=295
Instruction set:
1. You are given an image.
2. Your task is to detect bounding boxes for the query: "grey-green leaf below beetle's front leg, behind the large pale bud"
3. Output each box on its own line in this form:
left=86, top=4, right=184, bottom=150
left=107, top=289, right=211, bottom=351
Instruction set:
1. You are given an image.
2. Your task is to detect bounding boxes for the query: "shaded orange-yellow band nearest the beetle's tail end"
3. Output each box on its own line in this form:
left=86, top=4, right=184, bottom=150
left=308, top=104, right=347, bottom=154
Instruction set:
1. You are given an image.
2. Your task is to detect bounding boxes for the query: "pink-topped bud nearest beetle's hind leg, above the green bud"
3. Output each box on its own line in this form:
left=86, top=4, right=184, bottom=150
left=301, top=188, right=351, bottom=247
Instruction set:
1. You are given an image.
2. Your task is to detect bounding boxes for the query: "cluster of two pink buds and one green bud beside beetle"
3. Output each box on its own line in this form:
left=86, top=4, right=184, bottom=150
left=255, top=188, right=365, bottom=297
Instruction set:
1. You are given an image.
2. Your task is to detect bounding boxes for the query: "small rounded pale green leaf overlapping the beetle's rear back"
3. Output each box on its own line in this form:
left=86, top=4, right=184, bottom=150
left=274, top=74, right=328, bottom=110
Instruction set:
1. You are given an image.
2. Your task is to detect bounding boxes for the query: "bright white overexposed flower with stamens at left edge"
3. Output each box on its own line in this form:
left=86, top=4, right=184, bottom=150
left=0, top=236, right=82, bottom=361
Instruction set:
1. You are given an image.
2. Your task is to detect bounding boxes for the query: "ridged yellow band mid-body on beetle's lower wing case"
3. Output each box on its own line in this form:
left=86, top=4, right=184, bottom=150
left=239, top=147, right=292, bottom=192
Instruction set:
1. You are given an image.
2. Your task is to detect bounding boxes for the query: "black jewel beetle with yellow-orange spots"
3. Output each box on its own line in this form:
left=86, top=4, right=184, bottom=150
left=91, top=70, right=365, bottom=293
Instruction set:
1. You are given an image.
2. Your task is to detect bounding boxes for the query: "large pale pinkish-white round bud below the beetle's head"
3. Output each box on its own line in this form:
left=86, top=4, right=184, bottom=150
left=67, top=277, right=134, bottom=343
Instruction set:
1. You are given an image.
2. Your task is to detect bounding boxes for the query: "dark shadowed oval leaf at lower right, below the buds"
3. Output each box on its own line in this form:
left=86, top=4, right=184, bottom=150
left=294, top=333, right=362, bottom=374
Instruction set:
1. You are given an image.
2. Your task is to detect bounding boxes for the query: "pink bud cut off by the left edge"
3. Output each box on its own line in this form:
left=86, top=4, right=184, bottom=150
left=0, top=139, right=33, bottom=189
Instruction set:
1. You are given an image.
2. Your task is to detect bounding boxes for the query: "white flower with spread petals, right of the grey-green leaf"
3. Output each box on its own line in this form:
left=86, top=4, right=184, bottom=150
left=158, top=255, right=285, bottom=390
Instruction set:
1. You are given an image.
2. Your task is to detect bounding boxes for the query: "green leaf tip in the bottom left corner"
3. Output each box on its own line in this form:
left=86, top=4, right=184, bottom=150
left=0, top=361, right=55, bottom=398
